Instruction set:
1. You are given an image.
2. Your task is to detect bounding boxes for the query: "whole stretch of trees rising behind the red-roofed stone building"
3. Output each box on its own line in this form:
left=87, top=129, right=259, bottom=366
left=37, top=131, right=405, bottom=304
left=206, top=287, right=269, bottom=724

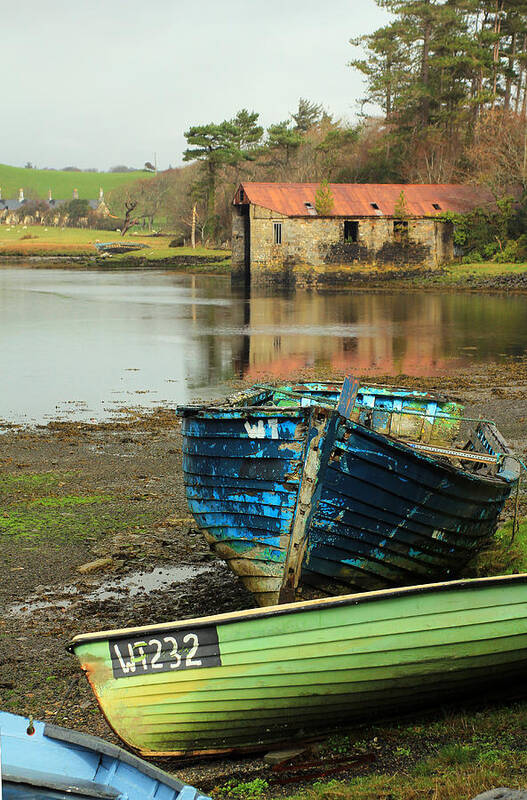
left=106, top=0, right=527, bottom=251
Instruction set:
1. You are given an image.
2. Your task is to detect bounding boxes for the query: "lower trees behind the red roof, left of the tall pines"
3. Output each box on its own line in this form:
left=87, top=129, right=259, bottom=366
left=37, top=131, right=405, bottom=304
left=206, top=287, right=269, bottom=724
left=110, top=98, right=368, bottom=242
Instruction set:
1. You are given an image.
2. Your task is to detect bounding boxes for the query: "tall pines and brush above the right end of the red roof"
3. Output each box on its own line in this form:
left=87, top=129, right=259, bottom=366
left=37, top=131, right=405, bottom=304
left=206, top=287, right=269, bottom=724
left=350, top=0, right=527, bottom=191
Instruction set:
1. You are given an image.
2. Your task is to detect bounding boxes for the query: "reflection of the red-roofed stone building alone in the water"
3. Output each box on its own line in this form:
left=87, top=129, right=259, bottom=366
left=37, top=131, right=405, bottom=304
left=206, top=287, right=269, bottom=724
left=229, top=288, right=466, bottom=380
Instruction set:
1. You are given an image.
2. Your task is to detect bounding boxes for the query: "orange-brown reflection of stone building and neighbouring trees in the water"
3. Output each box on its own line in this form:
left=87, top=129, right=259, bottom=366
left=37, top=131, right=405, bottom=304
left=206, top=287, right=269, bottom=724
left=228, top=290, right=527, bottom=379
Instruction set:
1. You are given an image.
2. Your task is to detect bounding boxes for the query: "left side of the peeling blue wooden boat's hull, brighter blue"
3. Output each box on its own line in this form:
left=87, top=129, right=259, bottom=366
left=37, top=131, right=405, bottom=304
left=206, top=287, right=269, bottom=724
left=182, top=408, right=329, bottom=606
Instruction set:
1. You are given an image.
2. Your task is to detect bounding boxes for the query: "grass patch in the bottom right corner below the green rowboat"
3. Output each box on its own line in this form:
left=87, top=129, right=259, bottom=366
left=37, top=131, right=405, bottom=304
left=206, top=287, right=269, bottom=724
left=256, top=703, right=527, bottom=800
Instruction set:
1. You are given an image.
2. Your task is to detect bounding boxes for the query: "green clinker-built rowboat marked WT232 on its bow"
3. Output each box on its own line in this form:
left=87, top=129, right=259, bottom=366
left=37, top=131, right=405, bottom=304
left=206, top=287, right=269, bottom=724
left=69, top=574, right=527, bottom=756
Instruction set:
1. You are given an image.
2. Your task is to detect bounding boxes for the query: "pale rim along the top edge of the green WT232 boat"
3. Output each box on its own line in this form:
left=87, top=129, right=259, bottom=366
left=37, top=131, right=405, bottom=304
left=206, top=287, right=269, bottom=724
left=66, top=573, right=527, bottom=653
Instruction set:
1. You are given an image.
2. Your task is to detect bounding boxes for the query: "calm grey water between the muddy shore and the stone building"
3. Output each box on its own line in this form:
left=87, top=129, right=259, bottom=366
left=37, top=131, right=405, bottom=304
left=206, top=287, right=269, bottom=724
left=0, top=268, right=527, bottom=423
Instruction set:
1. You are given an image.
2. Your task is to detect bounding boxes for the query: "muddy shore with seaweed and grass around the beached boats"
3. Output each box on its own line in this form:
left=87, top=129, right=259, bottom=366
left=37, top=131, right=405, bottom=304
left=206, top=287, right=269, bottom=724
left=0, top=359, right=527, bottom=800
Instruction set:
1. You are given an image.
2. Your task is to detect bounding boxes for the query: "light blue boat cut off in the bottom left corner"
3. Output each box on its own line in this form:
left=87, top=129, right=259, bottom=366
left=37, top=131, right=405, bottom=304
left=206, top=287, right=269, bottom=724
left=0, top=711, right=210, bottom=800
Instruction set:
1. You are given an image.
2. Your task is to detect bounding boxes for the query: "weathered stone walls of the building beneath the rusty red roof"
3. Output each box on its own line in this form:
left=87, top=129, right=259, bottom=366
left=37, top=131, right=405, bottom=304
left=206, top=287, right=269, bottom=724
left=232, top=205, right=454, bottom=283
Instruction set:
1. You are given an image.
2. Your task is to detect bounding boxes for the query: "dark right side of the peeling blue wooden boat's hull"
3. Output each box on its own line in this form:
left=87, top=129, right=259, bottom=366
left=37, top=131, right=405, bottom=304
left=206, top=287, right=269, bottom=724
left=302, top=420, right=512, bottom=594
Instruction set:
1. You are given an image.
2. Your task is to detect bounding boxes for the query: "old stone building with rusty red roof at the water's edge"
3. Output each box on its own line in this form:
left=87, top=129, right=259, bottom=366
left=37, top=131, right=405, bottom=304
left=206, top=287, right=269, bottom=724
left=232, top=182, right=493, bottom=283
